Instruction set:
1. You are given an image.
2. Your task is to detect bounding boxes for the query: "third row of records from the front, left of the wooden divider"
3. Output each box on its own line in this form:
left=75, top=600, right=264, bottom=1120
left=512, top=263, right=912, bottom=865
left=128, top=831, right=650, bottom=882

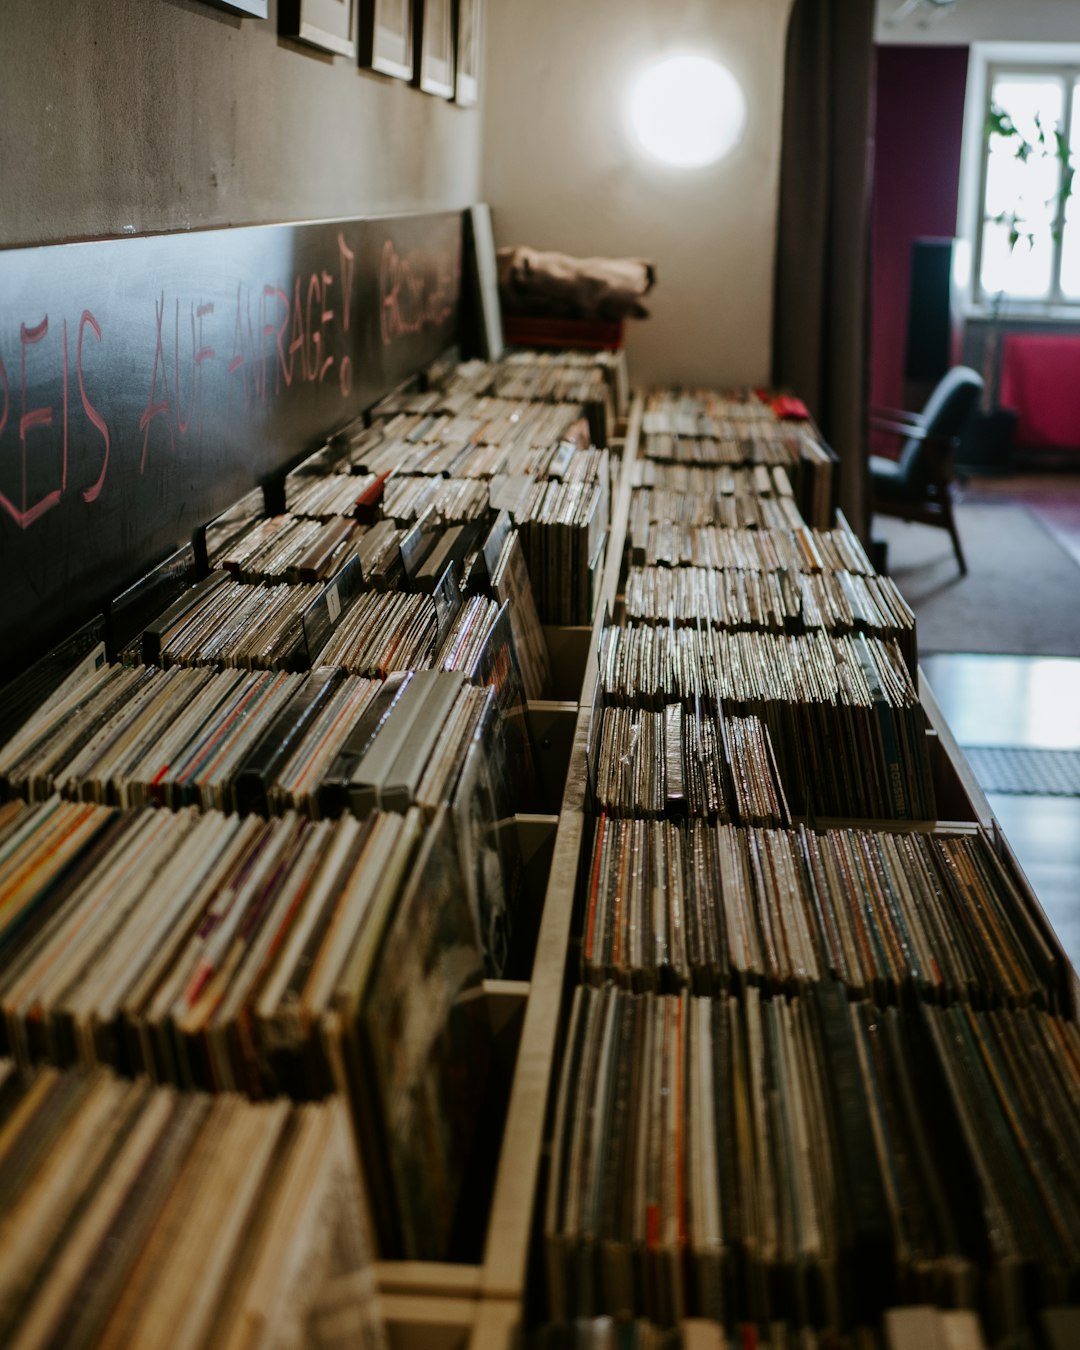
left=0, top=610, right=533, bottom=819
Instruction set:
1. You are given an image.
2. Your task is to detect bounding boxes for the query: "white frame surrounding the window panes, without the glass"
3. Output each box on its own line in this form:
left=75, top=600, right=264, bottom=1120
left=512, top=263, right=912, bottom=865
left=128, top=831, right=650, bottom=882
left=954, top=42, right=1080, bottom=324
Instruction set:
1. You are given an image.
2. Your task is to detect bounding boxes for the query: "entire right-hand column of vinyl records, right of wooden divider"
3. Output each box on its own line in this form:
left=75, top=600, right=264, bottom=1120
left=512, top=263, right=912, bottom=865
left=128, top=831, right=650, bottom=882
left=540, top=372, right=1080, bottom=1347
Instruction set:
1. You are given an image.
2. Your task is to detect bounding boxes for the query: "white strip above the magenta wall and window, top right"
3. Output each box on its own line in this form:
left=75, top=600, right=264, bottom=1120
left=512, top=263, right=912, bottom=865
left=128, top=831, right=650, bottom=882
left=875, top=0, right=1080, bottom=46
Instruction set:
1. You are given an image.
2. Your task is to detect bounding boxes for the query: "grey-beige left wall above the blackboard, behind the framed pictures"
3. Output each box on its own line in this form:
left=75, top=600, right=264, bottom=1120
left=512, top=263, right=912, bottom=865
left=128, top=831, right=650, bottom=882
left=0, top=0, right=482, bottom=244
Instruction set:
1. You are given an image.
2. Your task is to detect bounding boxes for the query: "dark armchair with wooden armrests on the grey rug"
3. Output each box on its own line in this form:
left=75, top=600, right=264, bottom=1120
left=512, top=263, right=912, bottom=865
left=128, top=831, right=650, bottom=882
left=869, top=366, right=983, bottom=575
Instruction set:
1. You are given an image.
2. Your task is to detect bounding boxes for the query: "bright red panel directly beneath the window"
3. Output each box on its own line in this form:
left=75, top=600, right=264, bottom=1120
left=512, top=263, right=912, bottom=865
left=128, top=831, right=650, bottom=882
left=999, top=333, right=1080, bottom=452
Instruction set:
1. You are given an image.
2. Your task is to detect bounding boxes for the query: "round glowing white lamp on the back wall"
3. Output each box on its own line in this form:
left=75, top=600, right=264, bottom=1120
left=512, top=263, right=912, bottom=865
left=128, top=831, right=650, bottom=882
left=629, top=55, right=747, bottom=169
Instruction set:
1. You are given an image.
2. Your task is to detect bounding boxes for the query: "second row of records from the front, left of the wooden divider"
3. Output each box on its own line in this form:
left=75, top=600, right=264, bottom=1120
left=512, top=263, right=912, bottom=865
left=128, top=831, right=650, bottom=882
left=0, top=798, right=494, bottom=1260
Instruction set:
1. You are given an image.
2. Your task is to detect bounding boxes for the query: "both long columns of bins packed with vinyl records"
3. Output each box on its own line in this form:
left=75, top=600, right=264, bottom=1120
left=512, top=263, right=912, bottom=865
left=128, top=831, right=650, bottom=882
left=0, top=352, right=1080, bottom=1350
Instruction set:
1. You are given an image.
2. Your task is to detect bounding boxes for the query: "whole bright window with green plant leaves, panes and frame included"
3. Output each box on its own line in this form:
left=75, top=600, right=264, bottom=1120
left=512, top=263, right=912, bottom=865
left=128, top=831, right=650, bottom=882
left=960, top=47, right=1080, bottom=311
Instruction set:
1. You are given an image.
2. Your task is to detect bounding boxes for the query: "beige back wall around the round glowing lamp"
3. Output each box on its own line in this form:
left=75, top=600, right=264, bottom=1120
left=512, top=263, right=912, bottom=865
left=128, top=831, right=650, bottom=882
left=482, top=0, right=791, bottom=383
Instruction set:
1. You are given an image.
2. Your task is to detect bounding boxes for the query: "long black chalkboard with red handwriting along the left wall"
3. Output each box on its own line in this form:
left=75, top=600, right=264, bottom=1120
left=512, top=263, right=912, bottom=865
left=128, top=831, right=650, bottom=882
left=0, top=212, right=462, bottom=679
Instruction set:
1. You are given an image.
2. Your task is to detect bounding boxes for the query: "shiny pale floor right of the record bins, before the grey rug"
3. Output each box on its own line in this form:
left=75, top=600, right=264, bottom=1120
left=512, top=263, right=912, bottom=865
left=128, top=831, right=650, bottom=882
left=922, top=650, right=1080, bottom=969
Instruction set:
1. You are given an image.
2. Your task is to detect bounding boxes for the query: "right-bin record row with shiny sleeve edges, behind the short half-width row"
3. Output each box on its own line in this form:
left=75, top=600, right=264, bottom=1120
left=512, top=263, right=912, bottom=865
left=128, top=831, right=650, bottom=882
left=590, top=625, right=936, bottom=819
